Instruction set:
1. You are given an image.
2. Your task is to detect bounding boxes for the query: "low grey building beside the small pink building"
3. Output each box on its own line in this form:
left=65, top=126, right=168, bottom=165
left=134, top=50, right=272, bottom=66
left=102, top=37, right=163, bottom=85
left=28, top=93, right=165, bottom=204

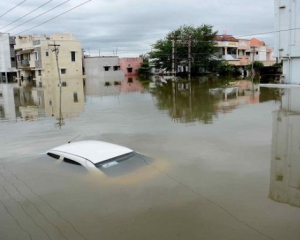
left=83, top=57, right=124, bottom=80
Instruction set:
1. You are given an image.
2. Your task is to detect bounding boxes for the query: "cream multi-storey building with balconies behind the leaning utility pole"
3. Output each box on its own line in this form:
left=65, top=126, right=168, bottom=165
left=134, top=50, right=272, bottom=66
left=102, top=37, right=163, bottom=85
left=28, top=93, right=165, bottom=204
left=15, top=34, right=83, bottom=87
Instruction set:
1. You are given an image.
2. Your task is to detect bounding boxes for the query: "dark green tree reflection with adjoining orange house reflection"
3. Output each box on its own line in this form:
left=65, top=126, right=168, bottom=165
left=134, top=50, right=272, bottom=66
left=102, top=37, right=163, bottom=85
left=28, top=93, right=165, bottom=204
left=150, top=80, right=279, bottom=124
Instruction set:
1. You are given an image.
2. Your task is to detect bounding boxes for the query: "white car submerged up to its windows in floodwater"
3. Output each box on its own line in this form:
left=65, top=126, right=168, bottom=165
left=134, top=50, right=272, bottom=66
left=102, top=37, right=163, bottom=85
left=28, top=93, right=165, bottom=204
left=47, top=140, right=148, bottom=176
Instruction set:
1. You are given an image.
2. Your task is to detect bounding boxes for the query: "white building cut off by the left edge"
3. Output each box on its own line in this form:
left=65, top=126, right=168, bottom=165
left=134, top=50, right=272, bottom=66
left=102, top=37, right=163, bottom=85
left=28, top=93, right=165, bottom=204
left=0, top=33, right=17, bottom=83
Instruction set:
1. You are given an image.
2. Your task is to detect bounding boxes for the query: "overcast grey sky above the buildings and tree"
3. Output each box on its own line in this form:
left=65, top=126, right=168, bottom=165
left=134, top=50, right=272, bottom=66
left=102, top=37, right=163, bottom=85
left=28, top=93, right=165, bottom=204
left=0, top=0, right=274, bottom=57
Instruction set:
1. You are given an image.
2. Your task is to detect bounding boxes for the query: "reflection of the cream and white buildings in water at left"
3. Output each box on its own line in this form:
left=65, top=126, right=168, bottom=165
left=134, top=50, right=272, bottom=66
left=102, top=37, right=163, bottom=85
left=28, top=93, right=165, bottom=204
left=0, top=79, right=85, bottom=125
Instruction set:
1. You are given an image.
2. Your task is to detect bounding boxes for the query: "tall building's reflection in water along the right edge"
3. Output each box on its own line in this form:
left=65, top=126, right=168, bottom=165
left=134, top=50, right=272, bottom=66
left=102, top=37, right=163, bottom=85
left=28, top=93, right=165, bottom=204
left=269, top=89, right=300, bottom=207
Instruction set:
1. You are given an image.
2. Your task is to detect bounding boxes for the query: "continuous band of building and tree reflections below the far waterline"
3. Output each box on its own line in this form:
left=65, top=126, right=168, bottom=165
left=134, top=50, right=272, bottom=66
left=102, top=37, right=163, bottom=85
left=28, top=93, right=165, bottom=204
left=0, top=77, right=280, bottom=126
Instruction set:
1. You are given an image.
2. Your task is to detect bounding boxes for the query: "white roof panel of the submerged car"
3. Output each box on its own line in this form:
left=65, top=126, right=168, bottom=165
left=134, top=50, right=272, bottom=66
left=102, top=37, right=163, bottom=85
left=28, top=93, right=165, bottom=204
left=48, top=140, right=133, bottom=164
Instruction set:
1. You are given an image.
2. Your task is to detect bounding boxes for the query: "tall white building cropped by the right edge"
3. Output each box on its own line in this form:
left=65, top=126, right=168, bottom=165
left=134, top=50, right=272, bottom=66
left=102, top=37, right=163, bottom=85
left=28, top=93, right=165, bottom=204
left=275, top=0, right=300, bottom=84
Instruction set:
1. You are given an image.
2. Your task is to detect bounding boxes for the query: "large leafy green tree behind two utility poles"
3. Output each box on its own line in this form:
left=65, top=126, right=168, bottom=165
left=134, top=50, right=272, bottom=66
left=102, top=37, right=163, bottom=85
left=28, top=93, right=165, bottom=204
left=149, top=24, right=217, bottom=74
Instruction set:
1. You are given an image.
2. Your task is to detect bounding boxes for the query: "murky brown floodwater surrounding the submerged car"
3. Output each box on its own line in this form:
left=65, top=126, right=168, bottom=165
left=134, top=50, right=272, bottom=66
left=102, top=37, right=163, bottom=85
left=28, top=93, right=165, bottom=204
left=0, top=77, right=300, bottom=240
